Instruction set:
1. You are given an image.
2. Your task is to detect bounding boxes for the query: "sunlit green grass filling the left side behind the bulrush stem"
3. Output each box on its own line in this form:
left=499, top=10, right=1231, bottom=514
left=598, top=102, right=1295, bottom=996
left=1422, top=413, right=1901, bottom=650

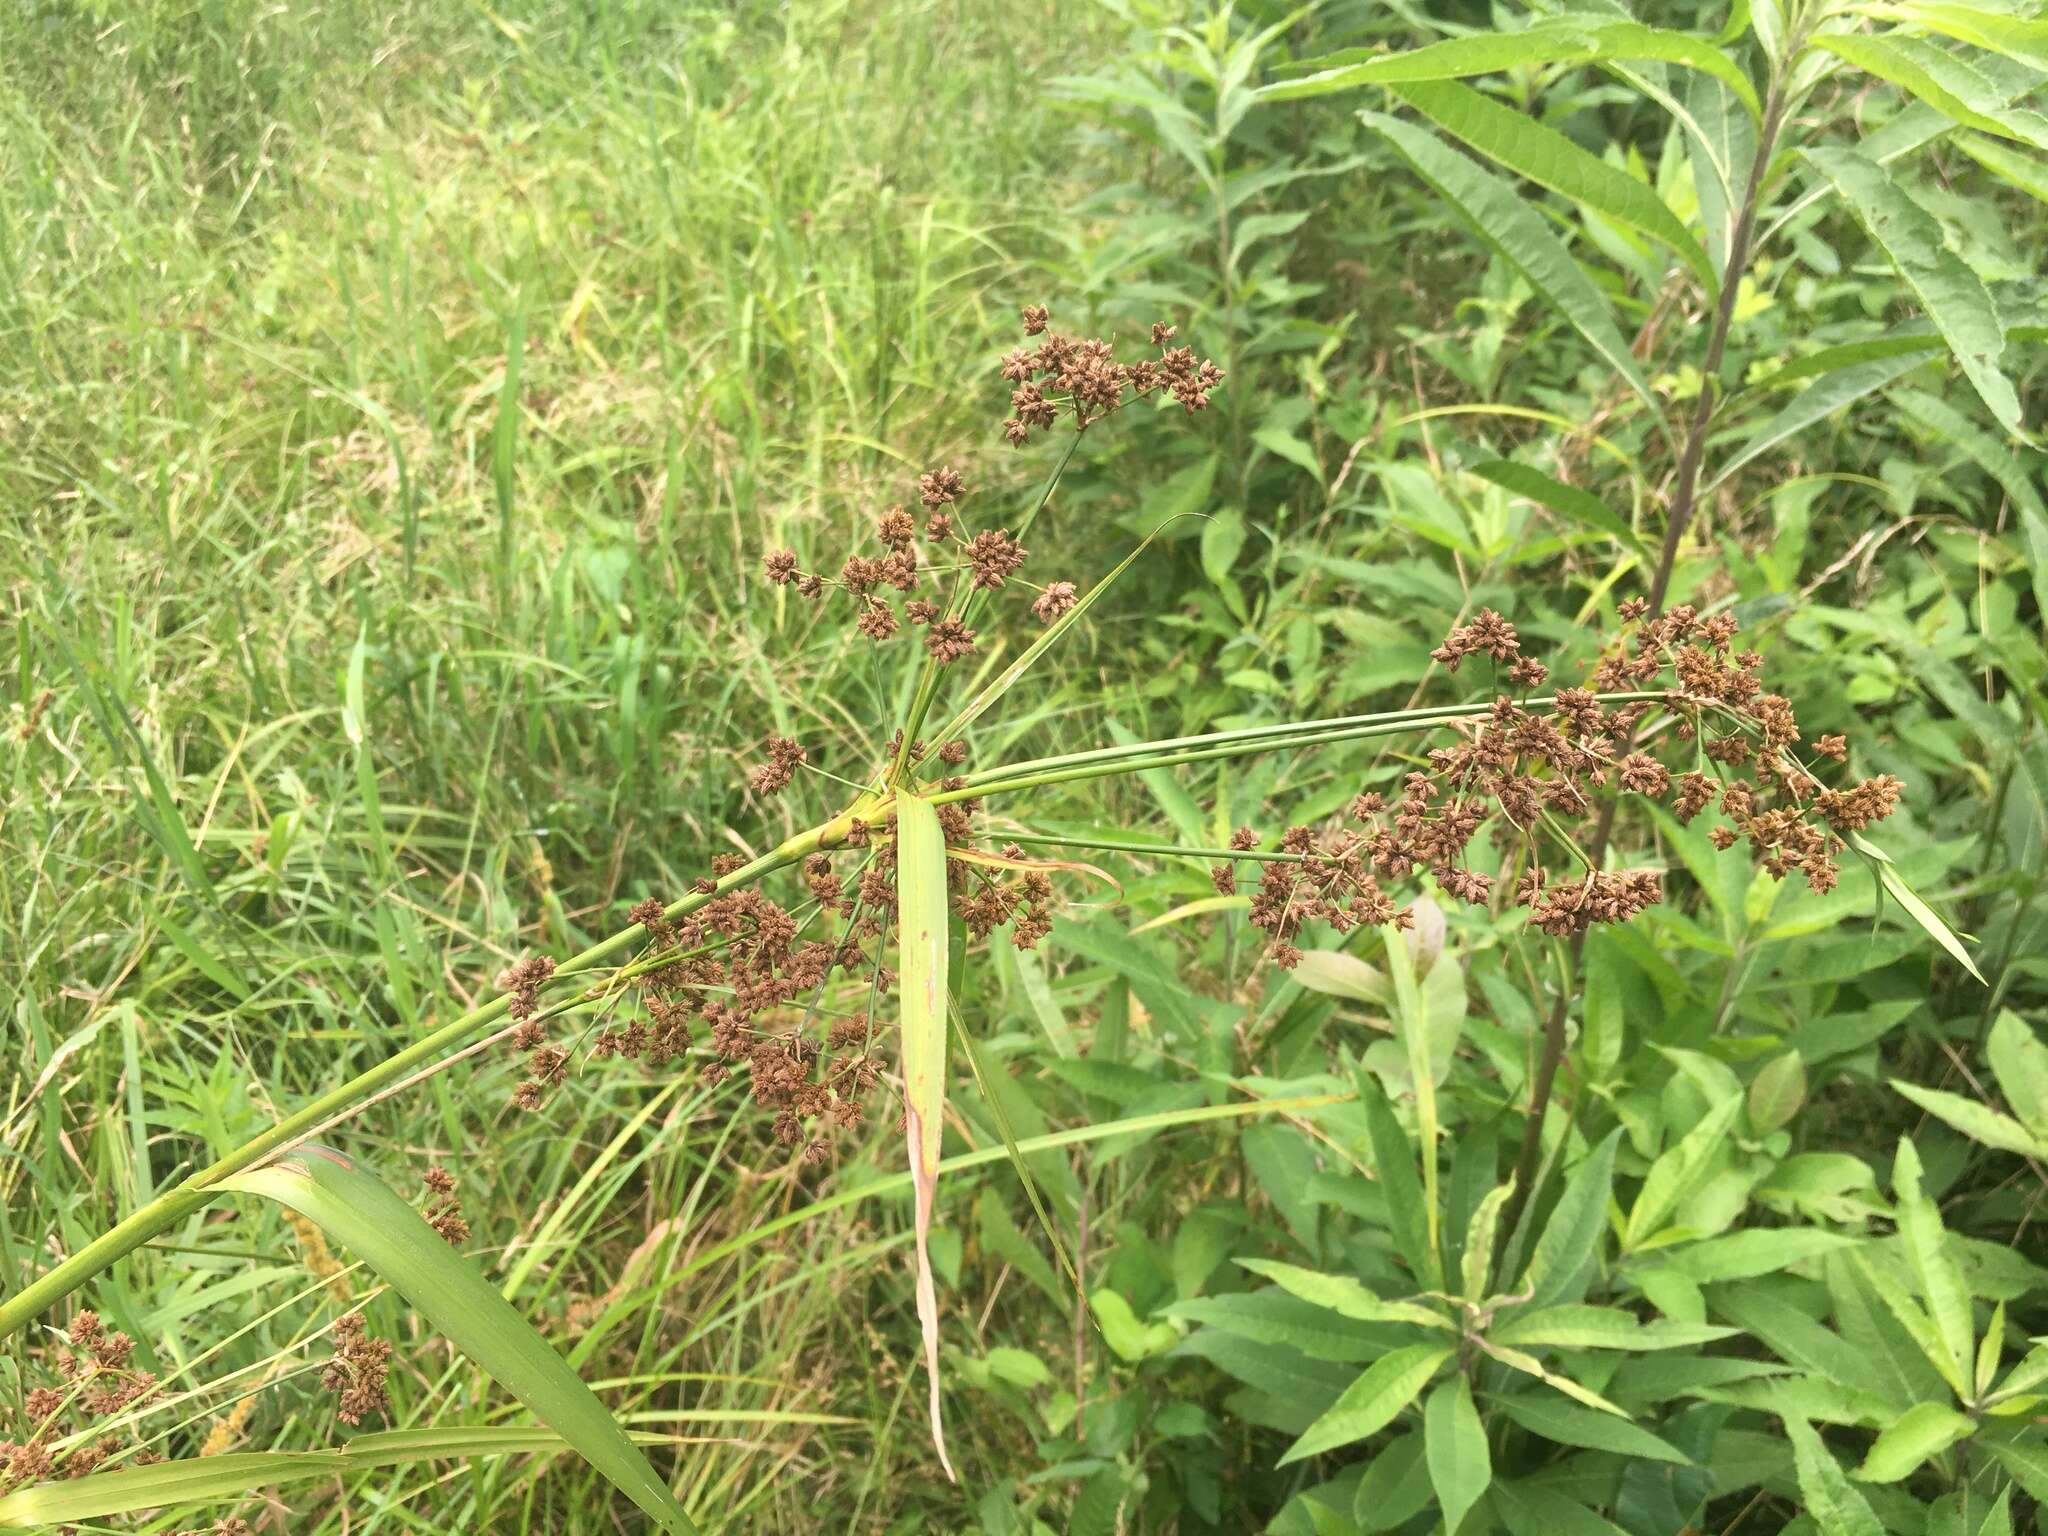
left=0, top=4, right=1122, bottom=1532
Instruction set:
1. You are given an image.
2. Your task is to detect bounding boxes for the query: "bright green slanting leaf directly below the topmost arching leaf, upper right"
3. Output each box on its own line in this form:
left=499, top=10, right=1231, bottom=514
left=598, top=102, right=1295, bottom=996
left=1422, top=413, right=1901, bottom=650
left=1393, top=80, right=1720, bottom=297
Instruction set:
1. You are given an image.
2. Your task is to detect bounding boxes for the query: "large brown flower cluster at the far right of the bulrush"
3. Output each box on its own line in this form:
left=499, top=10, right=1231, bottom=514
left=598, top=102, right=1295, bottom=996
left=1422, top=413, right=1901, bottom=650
left=1214, top=600, right=1903, bottom=967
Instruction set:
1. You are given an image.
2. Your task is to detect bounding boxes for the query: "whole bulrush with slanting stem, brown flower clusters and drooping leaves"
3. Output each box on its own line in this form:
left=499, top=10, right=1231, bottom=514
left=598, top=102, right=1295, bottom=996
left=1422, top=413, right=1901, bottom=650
left=0, top=307, right=1935, bottom=1530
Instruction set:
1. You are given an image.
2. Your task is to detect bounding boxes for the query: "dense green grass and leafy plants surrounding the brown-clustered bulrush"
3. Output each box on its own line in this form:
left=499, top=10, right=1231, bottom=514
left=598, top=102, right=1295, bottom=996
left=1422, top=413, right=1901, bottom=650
left=0, top=0, right=2048, bottom=1536
